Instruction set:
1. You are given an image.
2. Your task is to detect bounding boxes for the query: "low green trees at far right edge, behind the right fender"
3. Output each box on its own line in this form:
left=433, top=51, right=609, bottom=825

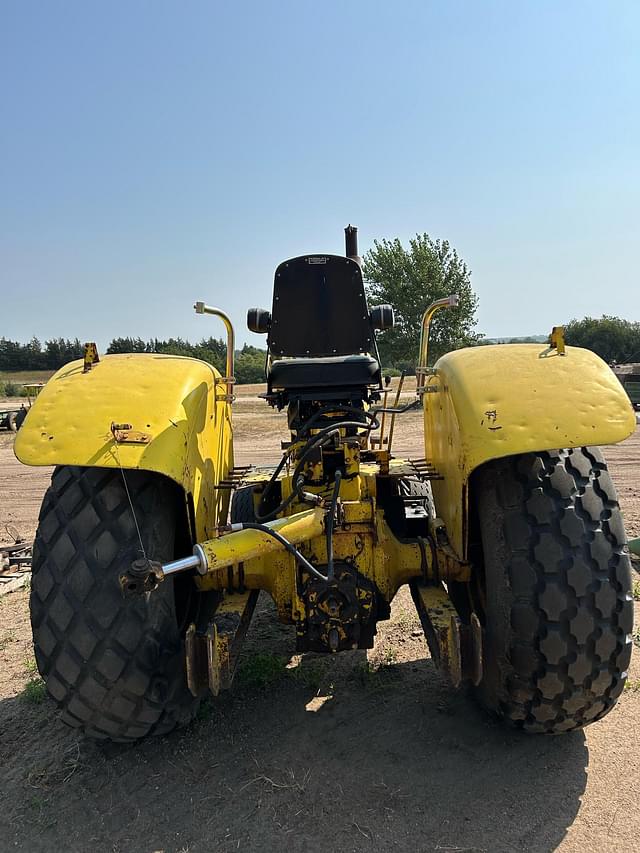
left=564, top=315, right=640, bottom=364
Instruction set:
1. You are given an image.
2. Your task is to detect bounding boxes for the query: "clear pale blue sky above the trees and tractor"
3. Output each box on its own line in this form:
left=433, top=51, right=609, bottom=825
left=0, top=0, right=640, bottom=346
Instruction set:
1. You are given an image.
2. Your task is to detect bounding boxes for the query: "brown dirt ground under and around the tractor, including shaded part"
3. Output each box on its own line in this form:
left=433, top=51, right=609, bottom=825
left=0, top=386, right=640, bottom=853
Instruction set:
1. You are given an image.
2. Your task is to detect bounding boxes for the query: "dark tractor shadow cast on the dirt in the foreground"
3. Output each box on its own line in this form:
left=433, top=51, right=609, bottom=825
left=0, top=604, right=589, bottom=853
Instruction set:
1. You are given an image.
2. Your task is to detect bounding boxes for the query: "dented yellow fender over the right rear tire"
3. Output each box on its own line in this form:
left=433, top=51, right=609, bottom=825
left=423, top=344, right=636, bottom=560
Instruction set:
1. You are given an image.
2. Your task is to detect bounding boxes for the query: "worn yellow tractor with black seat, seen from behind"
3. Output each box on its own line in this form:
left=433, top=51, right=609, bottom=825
left=15, top=227, right=636, bottom=741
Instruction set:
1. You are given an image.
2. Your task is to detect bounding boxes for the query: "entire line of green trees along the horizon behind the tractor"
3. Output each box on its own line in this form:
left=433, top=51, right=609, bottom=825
left=0, top=233, right=640, bottom=384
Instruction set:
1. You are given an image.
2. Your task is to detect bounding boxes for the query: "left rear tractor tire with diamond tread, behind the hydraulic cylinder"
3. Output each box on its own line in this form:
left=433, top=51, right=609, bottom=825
left=30, top=467, right=206, bottom=741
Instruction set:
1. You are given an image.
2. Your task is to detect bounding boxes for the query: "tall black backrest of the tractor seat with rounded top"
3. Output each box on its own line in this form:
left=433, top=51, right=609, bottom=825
left=267, top=255, right=377, bottom=358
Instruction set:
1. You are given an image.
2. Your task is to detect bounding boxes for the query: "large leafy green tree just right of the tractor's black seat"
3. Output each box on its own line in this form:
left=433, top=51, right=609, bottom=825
left=363, top=234, right=481, bottom=369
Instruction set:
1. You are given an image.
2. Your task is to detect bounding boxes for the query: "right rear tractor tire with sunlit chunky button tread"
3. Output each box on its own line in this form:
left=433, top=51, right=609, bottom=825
left=474, top=448, right=633, bottom=733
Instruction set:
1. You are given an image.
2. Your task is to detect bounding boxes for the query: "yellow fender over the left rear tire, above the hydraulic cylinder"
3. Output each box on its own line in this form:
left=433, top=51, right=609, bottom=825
left=15, top=354, right=233, bottom=540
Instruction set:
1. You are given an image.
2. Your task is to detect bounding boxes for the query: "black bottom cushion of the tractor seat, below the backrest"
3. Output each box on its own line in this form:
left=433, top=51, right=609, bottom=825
left=268, top=355, right=380, bottom=389
